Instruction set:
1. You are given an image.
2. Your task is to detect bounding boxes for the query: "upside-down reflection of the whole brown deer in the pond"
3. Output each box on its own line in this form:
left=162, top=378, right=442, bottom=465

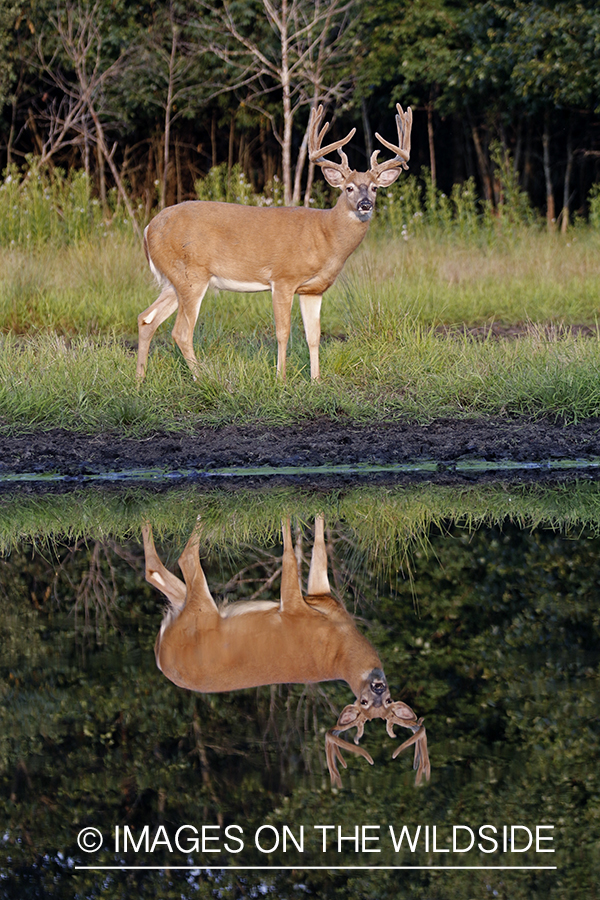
left=143, top=517, right=430, bottom=785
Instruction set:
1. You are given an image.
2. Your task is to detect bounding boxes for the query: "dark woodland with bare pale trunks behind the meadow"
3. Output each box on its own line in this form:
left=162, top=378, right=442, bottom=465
left=0, top=0, right=600, bottom=230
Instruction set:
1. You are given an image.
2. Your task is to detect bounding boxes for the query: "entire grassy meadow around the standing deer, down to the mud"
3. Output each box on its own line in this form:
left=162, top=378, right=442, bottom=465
left=0, top=228, right=600, bottom=434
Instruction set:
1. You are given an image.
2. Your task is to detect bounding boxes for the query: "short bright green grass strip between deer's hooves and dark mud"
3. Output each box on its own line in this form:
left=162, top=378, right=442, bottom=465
left=0, top=302, right=600, bottom=435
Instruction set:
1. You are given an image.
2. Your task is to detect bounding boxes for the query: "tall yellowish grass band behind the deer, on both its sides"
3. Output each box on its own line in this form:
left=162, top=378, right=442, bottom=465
left=0, top=227, right=600, bottom=343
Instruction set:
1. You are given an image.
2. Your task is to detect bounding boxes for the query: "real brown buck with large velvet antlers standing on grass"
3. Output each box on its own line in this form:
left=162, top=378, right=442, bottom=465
left=136, top=103, right=412, bottom=380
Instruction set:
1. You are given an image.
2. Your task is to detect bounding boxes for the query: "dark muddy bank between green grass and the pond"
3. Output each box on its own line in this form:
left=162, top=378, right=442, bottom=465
left=0, top=417, right=600, bottom=485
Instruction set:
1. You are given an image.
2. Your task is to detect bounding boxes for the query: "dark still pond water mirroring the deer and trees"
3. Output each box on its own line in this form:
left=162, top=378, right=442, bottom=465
left=0, top=480, right=600, bottom=900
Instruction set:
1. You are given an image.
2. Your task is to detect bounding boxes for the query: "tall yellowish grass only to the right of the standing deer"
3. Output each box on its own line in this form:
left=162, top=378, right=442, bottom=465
left=340, top=227, right=600, bottom=327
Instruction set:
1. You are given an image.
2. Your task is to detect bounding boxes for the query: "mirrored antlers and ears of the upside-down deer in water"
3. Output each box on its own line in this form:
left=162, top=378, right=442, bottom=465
left=325, top=700, right=431, bottom=787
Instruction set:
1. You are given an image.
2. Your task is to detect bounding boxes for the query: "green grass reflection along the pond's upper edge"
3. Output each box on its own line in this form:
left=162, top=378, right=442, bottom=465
left=0, top=481, right=600, bottom=567
